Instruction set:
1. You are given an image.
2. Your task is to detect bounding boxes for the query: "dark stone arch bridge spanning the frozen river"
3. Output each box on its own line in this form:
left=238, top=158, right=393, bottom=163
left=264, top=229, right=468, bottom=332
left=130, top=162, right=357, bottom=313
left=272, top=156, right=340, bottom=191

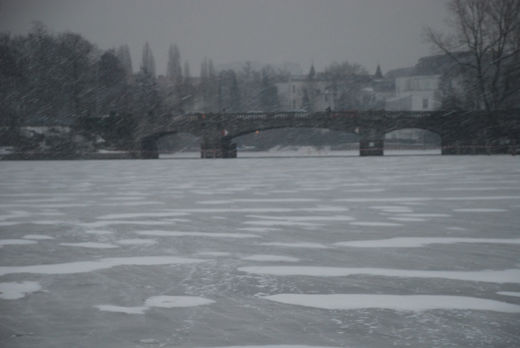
left=134, top=110, right=520, bottom=158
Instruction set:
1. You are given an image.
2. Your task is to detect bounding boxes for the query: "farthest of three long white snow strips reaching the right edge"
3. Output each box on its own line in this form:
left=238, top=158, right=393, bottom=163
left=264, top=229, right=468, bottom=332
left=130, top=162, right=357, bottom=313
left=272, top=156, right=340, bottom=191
left=334, top=237, right=520, bottom=248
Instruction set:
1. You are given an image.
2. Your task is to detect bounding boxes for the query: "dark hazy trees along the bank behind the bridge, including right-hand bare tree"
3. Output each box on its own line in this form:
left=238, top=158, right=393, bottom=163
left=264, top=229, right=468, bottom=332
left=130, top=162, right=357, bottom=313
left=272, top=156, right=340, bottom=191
left=0, top=0, right=520, bottom=152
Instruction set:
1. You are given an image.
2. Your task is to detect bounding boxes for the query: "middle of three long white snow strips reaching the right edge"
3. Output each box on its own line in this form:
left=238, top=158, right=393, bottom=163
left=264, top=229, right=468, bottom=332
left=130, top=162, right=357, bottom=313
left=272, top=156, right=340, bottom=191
left=238, top=266, right=520, bottom=284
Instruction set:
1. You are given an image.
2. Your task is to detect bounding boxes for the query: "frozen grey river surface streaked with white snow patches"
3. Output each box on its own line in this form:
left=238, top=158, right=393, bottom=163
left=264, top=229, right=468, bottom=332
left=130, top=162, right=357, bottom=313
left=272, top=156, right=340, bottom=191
left=0, top=156, right=520, bottom=348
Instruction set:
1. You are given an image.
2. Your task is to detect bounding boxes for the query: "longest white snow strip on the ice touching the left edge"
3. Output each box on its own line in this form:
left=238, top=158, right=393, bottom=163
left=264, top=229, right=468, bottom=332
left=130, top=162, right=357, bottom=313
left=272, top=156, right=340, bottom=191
left=0, top=256, right=206, bottom=276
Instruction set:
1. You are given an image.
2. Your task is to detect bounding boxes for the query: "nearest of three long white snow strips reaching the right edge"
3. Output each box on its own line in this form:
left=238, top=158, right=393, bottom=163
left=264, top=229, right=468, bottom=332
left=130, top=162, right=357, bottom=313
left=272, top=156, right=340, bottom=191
left=264, top=294, right=520, bottom=313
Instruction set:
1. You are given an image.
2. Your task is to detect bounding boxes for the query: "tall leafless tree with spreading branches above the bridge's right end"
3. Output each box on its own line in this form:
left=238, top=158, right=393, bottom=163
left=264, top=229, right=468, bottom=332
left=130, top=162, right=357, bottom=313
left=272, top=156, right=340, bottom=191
left=426, top=0, right=520, bottom=113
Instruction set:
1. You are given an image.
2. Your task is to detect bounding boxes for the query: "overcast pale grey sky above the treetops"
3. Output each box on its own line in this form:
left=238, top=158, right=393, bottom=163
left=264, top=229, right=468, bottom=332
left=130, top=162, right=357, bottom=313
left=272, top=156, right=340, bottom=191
left=0, top=0, right=447, bottom=75
